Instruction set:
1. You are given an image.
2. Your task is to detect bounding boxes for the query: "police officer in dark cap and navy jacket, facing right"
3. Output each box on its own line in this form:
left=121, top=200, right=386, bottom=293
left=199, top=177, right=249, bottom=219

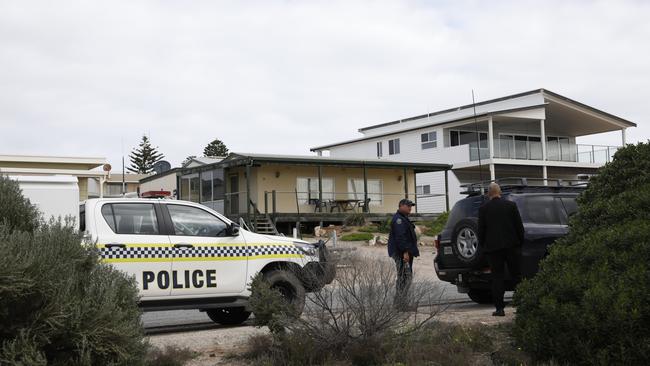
left=388, top=199, right=420, bottom=307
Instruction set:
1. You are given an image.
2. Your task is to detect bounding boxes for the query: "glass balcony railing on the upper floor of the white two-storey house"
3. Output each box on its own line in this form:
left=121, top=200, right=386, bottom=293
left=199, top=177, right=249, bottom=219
left=469, top=138, right=620, bottom=164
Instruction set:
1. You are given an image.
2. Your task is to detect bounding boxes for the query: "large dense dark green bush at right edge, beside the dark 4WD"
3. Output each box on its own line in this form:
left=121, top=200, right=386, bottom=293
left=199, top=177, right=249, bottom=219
left=514, top=143, right=650, bottom=365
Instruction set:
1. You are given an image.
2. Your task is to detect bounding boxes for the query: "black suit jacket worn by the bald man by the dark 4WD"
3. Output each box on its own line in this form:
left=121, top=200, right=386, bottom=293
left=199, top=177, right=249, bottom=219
left=478, top=198, right=524, bottom=253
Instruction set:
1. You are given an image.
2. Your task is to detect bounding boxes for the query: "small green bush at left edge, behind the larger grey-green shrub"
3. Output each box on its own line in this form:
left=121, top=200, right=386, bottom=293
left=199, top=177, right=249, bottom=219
left=0, top=175, right=40, bottom=232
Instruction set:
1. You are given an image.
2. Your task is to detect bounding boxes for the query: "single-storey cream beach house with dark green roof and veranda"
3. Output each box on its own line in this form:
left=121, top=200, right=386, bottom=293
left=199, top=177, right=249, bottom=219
left=140, top=153, right=451, bottom=232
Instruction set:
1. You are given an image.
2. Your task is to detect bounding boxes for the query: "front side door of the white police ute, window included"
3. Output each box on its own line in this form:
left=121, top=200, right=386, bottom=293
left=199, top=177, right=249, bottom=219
left=161, top=202, right=248, bottom=296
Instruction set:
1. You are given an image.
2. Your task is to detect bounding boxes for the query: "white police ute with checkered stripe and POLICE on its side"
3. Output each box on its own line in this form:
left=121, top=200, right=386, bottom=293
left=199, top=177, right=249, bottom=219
left=80, top=198, right=335, bottom=324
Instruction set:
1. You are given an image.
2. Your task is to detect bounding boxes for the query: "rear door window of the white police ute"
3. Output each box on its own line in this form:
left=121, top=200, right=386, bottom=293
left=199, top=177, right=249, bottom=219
left=102, top=203, right=158, bottom=235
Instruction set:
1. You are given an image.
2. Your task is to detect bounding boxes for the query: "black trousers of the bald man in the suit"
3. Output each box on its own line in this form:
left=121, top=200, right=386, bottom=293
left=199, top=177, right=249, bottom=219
left=485, top=248, right=521, bottom=310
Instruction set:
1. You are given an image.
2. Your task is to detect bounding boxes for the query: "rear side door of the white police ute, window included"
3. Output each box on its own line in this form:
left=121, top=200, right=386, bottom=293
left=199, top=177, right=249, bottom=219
left=97, top=202, right=172, bottom=300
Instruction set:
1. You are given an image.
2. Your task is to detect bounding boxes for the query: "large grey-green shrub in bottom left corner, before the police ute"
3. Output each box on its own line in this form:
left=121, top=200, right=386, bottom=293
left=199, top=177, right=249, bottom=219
left=0, top=222, right=146, bottom=365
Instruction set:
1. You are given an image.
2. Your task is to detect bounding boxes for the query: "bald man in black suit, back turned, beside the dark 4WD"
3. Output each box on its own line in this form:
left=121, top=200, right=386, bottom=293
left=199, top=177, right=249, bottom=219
left=478, top=183, right=524, bottom=316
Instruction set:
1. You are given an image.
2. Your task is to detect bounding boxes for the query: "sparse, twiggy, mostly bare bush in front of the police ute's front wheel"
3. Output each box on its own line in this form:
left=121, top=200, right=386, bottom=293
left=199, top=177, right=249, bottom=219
left=246, top=257, right=444, bottom=365
